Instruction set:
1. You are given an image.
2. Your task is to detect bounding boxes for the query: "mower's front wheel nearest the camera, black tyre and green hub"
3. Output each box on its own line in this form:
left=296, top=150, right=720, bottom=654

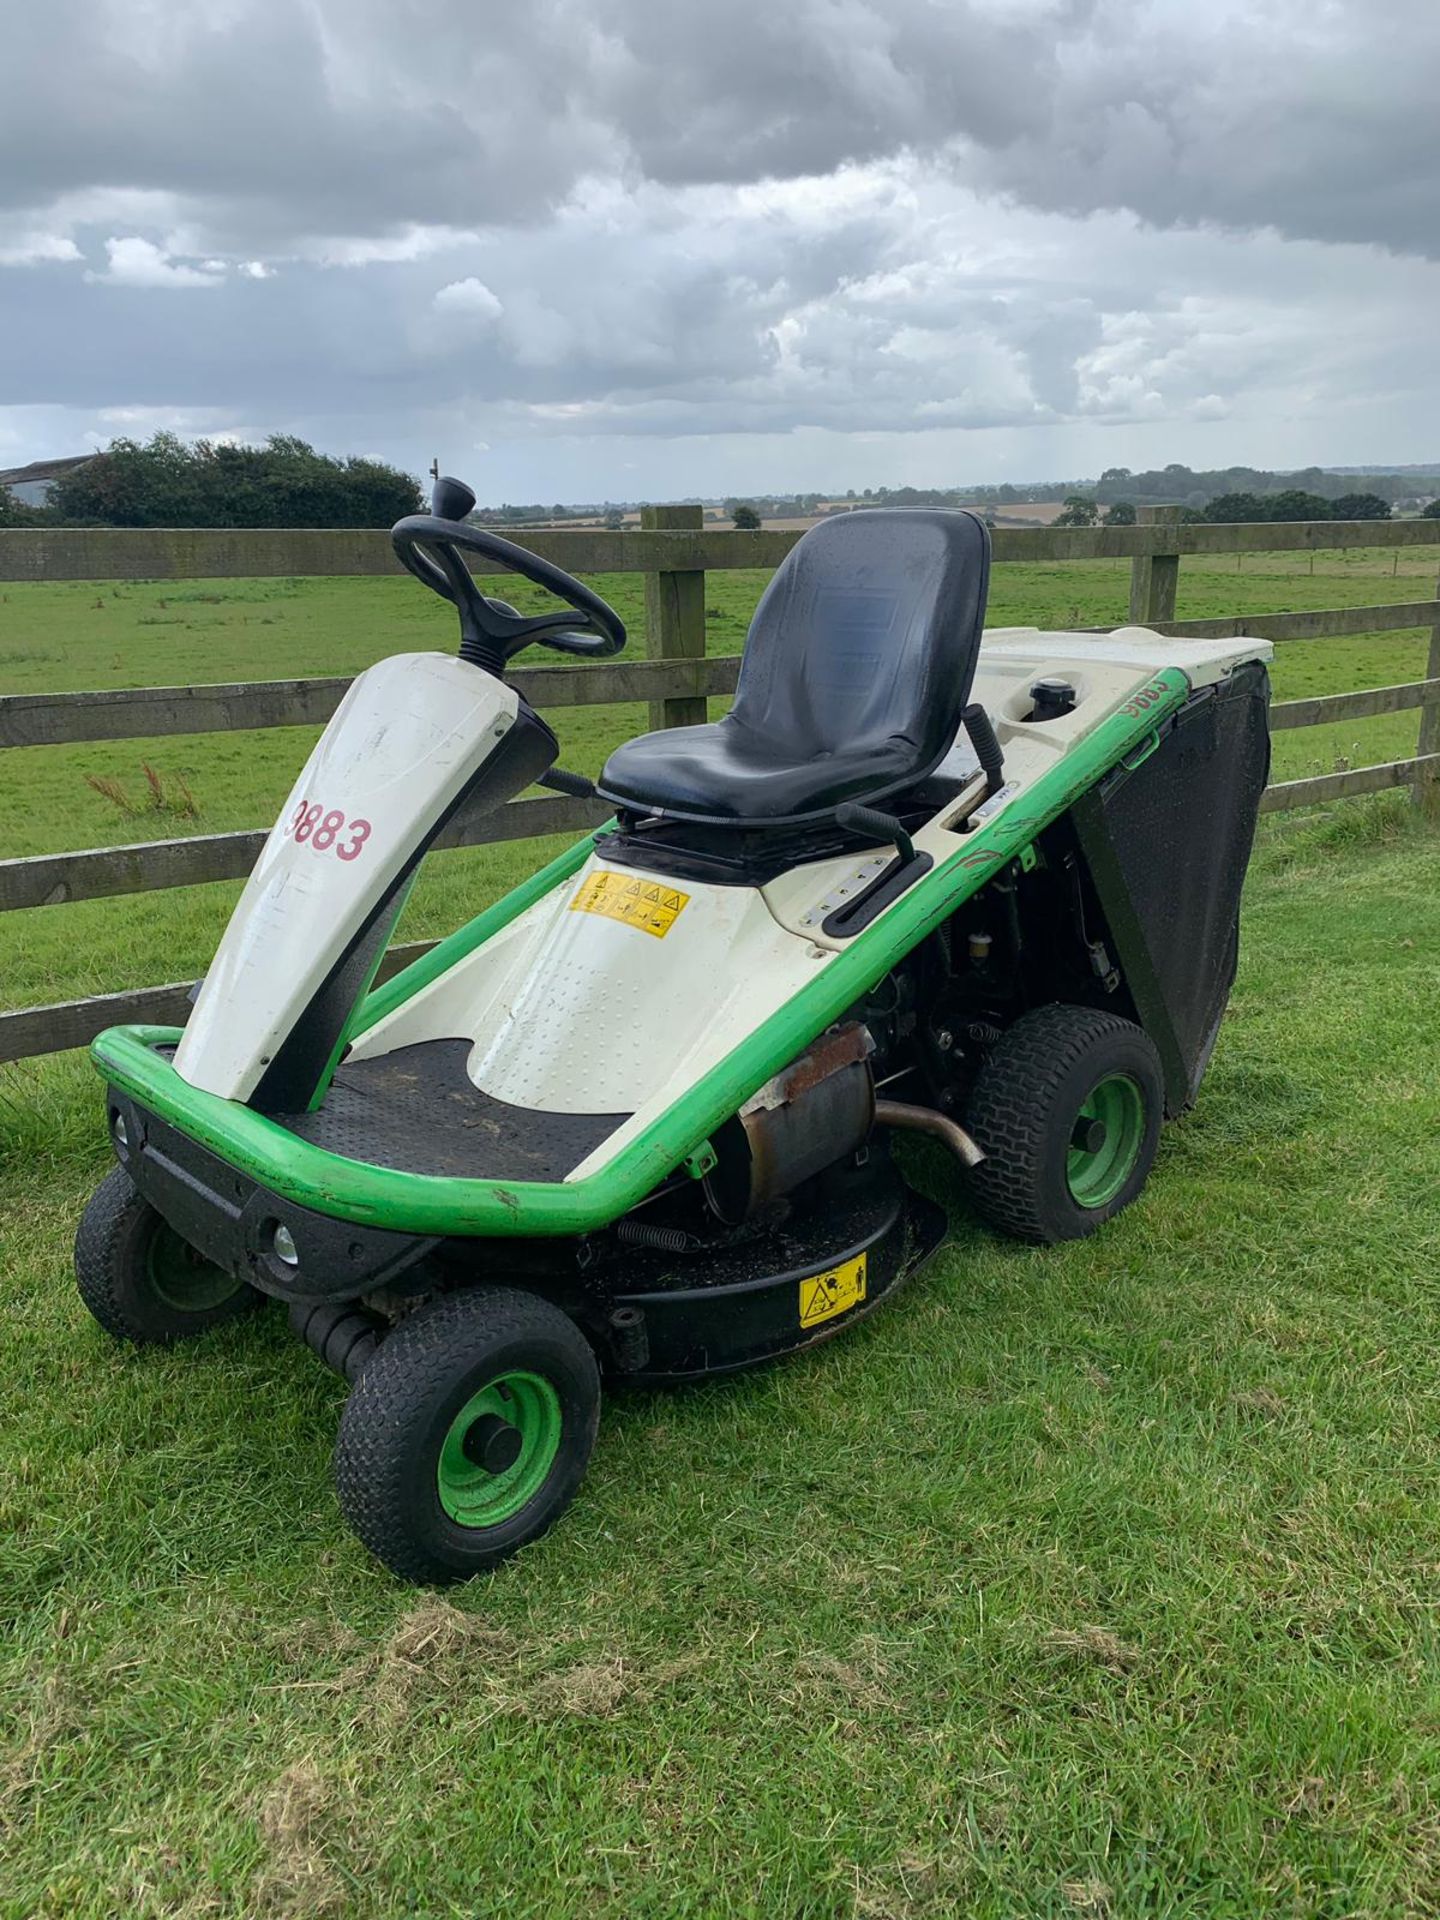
left=334, top=1286, right=601, bottom=1586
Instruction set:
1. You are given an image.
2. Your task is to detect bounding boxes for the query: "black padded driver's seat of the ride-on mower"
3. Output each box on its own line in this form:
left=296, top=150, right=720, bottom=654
left=599, top=509, right=991, bottom=828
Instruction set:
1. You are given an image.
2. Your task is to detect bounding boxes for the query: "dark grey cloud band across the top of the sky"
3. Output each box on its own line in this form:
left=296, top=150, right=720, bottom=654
left=0, top=0, right=1440, bottom=253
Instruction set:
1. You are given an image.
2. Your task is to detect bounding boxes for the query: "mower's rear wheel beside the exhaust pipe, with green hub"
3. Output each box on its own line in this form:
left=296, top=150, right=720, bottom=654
left=966, top=1006, right=1164, bottom=1244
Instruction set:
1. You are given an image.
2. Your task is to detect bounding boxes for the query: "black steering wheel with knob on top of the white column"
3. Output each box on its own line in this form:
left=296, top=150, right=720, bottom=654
left=390, top=478, right=626, bottom=674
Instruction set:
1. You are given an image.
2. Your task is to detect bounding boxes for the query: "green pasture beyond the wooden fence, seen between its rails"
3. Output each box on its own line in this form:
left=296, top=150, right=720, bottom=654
left=0, top=551, right=1434, bottom=1006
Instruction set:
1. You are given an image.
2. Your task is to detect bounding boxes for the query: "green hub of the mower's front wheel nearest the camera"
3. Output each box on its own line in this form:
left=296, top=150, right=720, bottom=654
left=436, top=1373, right=561, bottom=1526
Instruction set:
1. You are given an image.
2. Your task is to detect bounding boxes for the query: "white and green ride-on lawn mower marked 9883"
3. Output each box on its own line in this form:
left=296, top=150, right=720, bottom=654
left=75, top=480, right=1271, bottom=1582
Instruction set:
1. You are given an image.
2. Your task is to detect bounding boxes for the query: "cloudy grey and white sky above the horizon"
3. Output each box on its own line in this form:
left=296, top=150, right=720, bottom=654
left=0, top=0, right=1440, bottom=501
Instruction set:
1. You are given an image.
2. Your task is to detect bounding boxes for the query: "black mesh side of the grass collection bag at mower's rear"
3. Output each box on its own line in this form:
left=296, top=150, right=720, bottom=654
left=1073, top=660, right=1269, bottom=1112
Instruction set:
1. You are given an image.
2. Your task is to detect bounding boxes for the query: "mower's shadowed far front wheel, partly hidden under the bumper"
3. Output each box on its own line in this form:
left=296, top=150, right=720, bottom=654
left=75, top=1167, right=265, bottom=1346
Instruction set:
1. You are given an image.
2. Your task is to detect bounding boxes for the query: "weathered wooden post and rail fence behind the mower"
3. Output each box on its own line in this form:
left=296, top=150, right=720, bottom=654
left=0, top=507, right=1440, bottom=1062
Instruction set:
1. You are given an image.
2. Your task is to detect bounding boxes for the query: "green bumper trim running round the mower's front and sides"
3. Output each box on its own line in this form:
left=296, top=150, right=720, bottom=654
left=90, top=668, right=1188, bottom=1236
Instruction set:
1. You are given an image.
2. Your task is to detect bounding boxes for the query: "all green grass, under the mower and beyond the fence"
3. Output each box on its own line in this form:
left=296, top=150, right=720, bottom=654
left=0, top=559, right=1440, bottom=1920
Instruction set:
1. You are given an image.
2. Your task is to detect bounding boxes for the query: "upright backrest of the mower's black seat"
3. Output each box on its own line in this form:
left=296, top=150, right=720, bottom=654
left=730, top=507, right=991, bottom=780
